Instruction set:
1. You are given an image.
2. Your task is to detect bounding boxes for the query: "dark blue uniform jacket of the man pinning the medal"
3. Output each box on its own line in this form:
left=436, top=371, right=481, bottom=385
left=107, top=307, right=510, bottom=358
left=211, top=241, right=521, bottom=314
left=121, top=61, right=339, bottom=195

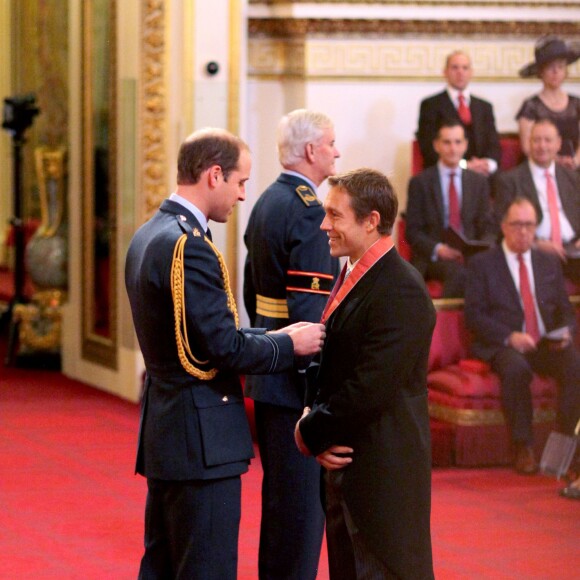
left=125, top=200, right=294, bottom=480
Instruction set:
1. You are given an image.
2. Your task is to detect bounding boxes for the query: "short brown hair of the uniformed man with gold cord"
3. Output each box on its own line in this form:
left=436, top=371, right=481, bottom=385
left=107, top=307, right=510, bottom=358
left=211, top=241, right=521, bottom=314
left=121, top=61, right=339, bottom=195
left=177, top=128, right=249, bottom=185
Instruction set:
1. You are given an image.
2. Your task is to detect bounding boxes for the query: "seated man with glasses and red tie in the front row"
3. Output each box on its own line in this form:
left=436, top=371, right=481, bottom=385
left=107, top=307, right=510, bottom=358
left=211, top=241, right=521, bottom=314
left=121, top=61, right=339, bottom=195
left=465, top=197, right=580, bottom=474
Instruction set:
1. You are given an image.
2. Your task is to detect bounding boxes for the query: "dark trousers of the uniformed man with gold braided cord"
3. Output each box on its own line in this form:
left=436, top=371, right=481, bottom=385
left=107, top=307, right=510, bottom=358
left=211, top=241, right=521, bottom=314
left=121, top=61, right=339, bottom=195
left=139, top=476, right=241, bottom=580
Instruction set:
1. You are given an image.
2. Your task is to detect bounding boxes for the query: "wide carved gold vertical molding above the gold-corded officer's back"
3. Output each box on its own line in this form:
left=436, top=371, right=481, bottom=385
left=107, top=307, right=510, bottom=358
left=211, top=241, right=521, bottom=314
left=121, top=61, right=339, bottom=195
left=140, top=0, right=167, bottom=218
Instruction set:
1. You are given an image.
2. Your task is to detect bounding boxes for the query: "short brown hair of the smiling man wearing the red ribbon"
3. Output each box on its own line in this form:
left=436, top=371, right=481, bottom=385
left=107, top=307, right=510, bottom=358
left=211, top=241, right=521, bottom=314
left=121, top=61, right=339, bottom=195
left=328, top=167, right=399, bottom=235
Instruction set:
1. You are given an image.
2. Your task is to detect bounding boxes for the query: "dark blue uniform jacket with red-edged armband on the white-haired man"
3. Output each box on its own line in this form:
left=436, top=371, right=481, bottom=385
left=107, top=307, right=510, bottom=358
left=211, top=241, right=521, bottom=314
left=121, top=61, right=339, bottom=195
left=244, top=173, right=339, bottom=409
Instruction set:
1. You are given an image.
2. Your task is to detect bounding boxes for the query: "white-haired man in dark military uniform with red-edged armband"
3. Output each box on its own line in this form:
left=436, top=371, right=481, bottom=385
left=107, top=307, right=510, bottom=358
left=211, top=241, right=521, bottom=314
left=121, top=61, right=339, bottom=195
left=244, top=109, right=339, bottom=580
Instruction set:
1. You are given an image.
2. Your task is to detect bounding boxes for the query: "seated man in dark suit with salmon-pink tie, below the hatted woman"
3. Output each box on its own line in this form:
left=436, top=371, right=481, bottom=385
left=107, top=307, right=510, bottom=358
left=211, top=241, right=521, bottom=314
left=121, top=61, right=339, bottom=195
left=495, top=119, right=580, bottom=274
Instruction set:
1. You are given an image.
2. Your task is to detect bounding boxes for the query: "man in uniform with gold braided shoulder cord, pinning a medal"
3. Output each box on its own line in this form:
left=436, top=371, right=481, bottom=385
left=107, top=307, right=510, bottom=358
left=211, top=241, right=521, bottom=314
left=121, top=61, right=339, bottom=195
left=125, top=129, right=324, bottom=580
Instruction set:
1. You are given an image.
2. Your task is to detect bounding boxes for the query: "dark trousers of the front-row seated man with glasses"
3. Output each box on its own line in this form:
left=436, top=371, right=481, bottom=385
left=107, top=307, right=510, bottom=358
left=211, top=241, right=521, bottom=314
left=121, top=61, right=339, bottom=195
left=491, top=340, right=580, bottom=445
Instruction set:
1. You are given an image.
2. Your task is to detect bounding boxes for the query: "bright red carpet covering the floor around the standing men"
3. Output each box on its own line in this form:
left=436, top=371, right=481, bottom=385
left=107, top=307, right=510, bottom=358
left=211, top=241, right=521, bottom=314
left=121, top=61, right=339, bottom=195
left=0, top=360, right=580, bottom=580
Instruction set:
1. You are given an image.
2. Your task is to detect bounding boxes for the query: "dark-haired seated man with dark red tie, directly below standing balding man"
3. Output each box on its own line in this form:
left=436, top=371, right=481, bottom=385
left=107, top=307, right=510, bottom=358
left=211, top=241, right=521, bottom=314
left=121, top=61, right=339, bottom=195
left=406, top=121, right=497, bottom=298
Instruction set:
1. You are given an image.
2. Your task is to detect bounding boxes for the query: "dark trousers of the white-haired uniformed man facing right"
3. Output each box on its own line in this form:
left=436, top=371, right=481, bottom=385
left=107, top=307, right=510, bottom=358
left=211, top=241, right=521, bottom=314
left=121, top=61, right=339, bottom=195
left=254, top=401, right=324, bottom=580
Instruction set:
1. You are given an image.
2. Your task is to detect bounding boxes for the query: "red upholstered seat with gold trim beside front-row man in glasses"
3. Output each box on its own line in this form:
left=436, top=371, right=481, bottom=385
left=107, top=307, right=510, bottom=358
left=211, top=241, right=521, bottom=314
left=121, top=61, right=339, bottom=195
left=427, top=309, right=557, bottom=466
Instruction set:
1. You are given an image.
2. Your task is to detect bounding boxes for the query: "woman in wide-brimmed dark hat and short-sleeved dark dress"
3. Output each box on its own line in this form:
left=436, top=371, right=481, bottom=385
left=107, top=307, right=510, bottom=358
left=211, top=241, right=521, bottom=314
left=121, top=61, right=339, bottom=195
left=516, top=35, right=580, bottom=169
